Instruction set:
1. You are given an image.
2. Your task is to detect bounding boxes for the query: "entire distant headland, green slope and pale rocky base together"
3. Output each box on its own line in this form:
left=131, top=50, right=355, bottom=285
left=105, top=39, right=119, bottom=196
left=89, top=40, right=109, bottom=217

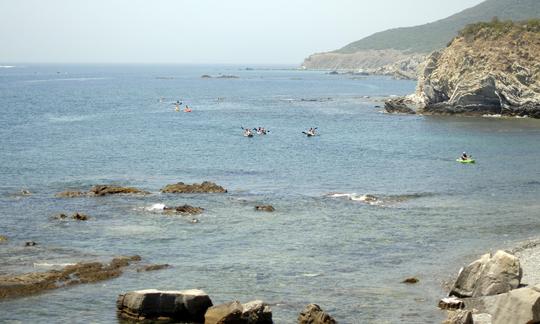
left=302, top=0, right=540, bottom=73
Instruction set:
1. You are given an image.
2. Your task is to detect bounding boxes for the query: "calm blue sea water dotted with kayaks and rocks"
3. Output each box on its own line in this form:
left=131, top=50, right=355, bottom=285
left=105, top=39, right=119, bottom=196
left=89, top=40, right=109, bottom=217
left=0, top=65, right=540, bottom=323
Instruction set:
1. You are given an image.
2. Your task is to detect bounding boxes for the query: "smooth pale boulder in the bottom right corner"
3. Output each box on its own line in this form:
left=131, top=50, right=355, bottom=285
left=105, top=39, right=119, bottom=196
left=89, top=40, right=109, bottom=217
left=464, top=285, right=540, bottom=324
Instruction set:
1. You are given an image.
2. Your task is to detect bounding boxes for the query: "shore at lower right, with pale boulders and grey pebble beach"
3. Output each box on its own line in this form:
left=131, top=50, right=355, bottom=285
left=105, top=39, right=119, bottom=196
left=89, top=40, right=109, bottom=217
left=439, top=240, right=540, bottom=324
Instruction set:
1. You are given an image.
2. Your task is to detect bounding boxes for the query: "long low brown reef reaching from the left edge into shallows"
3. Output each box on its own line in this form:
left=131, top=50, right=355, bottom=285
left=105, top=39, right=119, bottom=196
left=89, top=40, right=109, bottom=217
left=0, top=257, right=139, bottom=299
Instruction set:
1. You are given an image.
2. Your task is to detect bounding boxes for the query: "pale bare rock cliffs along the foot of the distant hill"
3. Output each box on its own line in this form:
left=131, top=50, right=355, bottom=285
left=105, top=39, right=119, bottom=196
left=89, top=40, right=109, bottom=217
left=302, top=49, right=426, bottom=79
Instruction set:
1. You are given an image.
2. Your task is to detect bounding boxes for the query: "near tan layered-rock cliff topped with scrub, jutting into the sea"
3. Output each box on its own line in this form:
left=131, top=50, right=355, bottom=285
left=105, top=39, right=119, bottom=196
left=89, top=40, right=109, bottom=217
left=385, top=20, right=540, bottom=118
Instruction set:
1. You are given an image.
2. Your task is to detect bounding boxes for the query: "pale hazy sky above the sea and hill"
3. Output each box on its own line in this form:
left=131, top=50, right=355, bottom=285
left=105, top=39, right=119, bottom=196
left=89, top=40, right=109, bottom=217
left=0, top=0, right=482, bottom=64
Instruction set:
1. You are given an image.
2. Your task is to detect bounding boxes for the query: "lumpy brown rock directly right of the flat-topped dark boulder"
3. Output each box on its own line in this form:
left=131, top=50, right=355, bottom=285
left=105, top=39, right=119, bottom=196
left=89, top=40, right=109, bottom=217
left=204, top=300, right=273, bottom=324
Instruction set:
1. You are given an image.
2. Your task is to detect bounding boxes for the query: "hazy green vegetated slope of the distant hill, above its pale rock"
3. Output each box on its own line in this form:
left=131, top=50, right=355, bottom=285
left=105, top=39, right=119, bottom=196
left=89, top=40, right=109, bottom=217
left=335, top=0, right=540, bottom=53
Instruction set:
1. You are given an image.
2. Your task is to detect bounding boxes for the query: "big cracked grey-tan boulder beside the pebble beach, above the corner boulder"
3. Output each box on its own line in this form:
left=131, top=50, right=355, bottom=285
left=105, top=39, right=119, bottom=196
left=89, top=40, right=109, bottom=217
left=450, top=250, right=522, bottom=298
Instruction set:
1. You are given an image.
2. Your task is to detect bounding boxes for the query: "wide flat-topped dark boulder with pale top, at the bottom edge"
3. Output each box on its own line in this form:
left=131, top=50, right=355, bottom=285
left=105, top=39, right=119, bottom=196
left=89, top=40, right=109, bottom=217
left=116, top=289, right=212, bottom=323
